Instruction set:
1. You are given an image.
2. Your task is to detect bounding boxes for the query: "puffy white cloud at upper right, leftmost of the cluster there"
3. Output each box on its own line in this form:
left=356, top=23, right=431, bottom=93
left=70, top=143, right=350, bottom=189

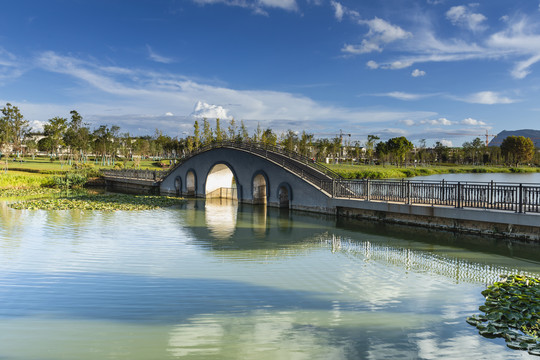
left=342, top=17, right=412, bottom=55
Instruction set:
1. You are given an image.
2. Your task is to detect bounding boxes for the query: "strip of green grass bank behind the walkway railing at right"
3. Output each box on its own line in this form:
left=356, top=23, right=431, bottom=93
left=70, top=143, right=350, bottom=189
left=325, top=164, right=540, bottom=179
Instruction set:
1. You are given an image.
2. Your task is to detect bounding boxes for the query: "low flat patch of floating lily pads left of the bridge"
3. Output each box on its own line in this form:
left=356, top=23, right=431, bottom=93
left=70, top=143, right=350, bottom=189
left=9, top=193, right=183, bottom=211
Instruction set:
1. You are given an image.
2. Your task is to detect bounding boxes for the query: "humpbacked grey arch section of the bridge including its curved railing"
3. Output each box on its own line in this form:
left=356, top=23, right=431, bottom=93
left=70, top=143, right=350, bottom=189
left=160, top=142, right=335, bottom=213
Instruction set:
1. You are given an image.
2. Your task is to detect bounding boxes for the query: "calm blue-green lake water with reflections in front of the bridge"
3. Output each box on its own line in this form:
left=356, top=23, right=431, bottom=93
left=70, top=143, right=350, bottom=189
left=0, top=201, right=540, bottom=360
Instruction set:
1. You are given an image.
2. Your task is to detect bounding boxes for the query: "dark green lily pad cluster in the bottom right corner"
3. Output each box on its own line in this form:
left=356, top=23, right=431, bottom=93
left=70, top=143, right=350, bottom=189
left=467, top=275, right=540, bottom=356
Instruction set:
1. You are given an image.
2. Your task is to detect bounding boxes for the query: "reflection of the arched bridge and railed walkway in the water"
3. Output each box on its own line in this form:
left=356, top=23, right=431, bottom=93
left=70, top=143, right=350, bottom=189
left=178, top=199, right=540, bottom=284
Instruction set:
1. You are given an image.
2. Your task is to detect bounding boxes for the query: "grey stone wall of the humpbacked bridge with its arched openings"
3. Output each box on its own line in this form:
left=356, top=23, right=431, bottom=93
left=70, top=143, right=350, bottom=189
left=160, top=147, right=329, bottom=209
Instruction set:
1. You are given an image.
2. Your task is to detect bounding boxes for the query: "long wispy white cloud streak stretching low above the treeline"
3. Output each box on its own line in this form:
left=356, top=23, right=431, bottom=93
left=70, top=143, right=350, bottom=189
left=27, top=51, right=434, bottom=132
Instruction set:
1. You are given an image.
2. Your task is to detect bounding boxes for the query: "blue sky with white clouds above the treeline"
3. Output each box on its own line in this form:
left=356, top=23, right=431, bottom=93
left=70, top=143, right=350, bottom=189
left=0, top=0, right=540, bottom=146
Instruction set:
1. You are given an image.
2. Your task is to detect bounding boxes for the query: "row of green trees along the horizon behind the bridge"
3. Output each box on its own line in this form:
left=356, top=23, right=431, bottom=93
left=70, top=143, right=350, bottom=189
left=0, top=103, right=540, bottom=166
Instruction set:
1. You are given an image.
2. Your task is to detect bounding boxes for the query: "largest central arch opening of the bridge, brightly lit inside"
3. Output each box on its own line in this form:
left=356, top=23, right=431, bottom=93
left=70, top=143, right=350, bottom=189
left=204, top=161, right=240, bottom=200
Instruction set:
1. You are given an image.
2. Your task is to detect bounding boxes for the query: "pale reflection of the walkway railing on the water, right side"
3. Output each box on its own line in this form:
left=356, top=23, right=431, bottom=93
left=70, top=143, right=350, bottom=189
left=320, top=234, right=538, bottom=284
